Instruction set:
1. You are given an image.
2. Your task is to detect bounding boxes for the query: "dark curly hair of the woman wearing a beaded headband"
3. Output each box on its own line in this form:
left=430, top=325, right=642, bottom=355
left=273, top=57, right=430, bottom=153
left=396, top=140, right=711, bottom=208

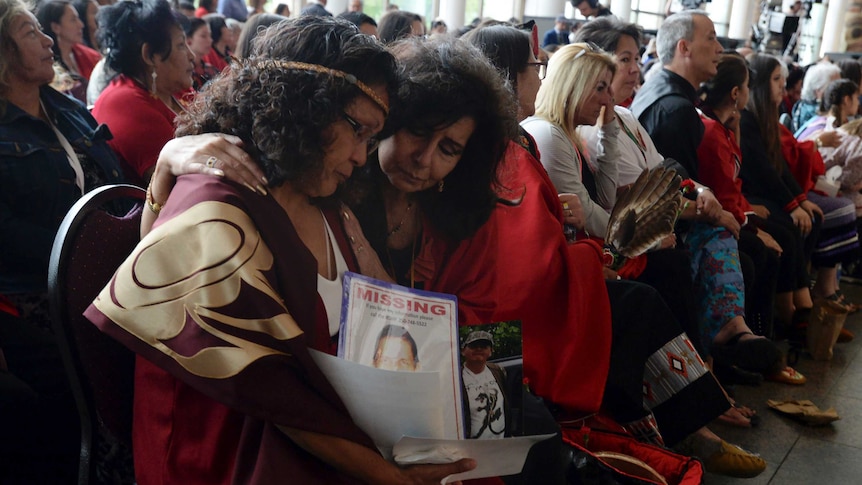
left=177, top=17, right=397, bottom=187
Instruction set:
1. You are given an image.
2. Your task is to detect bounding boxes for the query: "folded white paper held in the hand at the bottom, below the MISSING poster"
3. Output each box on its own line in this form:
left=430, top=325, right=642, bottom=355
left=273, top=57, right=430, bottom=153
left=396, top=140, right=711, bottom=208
left=393, top=434, right=554, bottom=483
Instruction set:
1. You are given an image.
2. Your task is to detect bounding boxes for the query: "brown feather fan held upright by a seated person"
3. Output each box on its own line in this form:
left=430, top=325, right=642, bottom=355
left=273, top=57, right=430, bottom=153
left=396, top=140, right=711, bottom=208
left=605, top=167, right=682, bottom=264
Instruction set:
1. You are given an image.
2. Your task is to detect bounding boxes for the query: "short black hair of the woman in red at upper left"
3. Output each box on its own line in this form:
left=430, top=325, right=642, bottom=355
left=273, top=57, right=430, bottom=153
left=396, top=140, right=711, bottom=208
left=97, top=0, right=187, bottom=76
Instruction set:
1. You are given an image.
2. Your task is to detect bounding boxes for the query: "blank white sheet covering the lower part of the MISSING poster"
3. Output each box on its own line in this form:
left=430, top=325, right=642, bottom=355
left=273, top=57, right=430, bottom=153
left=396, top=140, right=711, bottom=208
left=309, top=349, right=444, bottom=459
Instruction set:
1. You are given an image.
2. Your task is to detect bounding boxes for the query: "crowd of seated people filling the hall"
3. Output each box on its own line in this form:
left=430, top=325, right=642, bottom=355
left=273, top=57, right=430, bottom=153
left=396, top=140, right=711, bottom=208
left=5, top=0, right=862, bottom=484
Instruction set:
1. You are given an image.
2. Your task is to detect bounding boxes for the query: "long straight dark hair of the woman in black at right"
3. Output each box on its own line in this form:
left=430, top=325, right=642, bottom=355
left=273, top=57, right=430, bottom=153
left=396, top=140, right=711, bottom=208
left=745, top=54, right=787, bottom=172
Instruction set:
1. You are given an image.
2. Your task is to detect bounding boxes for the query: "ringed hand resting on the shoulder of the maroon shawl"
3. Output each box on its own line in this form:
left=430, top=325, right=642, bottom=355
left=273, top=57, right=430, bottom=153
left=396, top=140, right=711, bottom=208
left=156, top=133, right=267, bottom=194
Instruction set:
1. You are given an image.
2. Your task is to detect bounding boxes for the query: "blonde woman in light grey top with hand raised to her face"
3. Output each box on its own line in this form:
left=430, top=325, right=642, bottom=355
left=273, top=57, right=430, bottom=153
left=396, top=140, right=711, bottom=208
left=521, top=44, right=620, bottom=236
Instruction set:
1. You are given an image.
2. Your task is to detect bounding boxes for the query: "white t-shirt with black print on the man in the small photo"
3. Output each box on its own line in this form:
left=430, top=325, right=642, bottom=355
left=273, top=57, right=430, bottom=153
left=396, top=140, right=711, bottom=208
left=461, top=366, right=506, bottom=439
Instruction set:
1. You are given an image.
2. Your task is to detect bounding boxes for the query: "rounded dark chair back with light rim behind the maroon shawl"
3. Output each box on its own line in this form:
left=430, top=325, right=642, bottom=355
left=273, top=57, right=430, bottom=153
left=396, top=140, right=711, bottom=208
left=48, top=185, right=145, bottom=484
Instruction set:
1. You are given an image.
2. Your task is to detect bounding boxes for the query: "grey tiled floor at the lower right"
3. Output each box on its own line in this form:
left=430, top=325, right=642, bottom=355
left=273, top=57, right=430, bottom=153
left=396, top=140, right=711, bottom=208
left=705, top=283, right=862, bottom=485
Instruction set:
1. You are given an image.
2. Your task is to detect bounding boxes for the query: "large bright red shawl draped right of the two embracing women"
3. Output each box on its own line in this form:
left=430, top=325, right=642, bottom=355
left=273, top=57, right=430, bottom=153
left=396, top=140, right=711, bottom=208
left=417, top=142, right=611, bottom=412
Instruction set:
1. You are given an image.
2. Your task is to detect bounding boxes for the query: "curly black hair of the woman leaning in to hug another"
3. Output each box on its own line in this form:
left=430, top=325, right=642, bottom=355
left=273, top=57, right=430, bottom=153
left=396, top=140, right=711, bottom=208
left=348, top=37, right=518, bottom=248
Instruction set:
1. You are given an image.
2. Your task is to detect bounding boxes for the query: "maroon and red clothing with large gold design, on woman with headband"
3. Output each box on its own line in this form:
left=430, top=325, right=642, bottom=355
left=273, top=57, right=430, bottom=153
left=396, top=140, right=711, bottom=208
left=85, top=175, right=376, bottom=485
